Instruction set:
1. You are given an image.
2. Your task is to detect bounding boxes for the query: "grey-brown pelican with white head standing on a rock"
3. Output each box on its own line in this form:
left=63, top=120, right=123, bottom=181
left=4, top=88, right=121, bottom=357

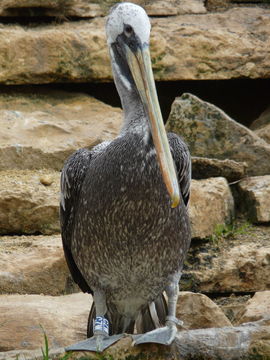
left=60, top=2, right=191, bottom=351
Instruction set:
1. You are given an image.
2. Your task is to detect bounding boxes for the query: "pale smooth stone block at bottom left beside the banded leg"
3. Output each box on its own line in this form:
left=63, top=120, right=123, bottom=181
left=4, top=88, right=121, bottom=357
left=0, top=293, right=92, bottom=352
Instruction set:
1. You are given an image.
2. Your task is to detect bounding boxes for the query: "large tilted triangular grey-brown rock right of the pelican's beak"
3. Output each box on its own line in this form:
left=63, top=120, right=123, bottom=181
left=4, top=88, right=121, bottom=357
left=166, top=94, right=270, bottom=175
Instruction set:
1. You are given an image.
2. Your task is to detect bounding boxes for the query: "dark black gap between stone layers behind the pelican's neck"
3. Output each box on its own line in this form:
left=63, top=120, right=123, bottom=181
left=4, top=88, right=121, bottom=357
left=0, top=79, right=270, bottom=127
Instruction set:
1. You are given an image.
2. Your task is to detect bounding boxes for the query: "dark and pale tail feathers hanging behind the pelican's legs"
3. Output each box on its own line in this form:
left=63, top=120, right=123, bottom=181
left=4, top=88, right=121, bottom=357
left=87, top=294, right=168, bottom=338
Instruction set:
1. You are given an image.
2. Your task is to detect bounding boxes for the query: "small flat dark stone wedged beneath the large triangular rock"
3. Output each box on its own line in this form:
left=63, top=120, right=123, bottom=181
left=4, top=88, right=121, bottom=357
left=192, top=156, right=247, bottom=182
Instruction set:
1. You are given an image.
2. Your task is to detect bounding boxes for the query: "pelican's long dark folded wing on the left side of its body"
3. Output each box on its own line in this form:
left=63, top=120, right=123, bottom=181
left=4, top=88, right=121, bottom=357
left=60, top=149, right=92, bottom=293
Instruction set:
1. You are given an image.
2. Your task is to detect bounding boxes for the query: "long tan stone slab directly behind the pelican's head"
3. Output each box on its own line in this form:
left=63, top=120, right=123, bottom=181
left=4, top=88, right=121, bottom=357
left=0, top=7, right=270, bottom=84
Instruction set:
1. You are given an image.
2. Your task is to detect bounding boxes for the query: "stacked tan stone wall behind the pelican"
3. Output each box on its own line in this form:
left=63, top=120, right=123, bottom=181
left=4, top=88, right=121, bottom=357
left=0, top=0, right=270, bottom=359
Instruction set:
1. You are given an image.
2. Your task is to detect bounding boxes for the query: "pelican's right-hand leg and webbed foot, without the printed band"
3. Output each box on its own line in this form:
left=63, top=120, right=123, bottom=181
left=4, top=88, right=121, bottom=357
left=133, top=272, right=183, bottom=345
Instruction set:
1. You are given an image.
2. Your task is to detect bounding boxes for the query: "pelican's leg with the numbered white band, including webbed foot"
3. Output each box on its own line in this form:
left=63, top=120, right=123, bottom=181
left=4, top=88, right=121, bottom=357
left=65, top=290, right=124, bottom=352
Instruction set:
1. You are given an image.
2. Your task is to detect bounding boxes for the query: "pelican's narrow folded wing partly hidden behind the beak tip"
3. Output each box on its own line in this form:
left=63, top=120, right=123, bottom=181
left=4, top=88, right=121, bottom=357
left=168, top=133, right=191, bottom=206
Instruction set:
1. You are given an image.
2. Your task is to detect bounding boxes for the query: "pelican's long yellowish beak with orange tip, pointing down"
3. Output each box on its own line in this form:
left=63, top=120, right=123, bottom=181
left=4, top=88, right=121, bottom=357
left=125, top=45, right=180, bottom=208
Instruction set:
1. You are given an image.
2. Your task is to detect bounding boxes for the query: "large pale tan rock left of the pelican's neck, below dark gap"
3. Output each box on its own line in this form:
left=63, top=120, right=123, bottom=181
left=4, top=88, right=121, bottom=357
left=0, top=88, right=122, bottom=170
